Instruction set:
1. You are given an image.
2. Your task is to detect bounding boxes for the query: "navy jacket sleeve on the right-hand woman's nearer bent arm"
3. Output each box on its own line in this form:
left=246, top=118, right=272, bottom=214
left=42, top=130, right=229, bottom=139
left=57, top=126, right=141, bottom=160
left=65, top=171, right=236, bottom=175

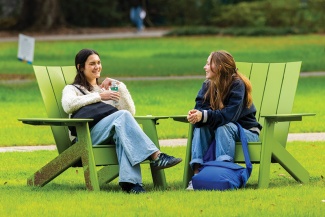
left=199, top=81, right=245, bottom=129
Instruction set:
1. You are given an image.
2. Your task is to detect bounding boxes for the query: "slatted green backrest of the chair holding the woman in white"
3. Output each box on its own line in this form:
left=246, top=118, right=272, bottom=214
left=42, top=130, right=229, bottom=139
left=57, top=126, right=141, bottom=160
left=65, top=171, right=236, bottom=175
left=33, top=66, right=76, bottom=153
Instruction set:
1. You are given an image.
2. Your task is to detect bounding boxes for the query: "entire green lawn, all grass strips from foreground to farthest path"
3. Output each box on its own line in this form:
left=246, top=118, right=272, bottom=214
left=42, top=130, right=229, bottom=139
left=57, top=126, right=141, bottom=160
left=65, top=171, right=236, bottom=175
left=0, top=35, right=325, bottom=217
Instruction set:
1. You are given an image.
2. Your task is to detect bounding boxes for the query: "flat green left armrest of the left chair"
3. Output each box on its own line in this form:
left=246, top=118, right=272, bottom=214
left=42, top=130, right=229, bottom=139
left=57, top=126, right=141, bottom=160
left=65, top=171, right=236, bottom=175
left=18, top=118, right=93, bottom=126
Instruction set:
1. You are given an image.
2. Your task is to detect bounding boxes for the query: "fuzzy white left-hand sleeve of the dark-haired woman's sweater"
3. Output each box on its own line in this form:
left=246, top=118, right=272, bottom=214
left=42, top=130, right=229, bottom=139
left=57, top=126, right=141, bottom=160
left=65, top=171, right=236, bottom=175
left=62, top=85, right=101, bottom=114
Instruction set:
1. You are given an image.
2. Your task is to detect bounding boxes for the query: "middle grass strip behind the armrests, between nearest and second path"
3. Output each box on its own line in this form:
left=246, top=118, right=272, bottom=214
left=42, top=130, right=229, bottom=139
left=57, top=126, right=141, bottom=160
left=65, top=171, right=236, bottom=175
left=0, top=77, right=325, bottom=146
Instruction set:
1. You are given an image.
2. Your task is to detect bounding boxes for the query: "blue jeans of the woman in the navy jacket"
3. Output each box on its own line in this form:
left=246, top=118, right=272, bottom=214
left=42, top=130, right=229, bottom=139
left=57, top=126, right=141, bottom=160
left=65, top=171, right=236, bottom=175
left=190, top=123, right=259, bottom=168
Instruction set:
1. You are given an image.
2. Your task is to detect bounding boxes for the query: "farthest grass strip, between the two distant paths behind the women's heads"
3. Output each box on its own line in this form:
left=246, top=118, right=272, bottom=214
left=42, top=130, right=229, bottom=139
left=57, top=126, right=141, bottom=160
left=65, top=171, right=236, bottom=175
left=0, top=35, right=325, bottom=77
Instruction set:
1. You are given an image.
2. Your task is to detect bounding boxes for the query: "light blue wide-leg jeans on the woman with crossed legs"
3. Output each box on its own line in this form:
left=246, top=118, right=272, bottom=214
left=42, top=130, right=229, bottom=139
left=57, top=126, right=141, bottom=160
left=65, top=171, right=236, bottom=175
left=90, top=110, right=158, bottom=184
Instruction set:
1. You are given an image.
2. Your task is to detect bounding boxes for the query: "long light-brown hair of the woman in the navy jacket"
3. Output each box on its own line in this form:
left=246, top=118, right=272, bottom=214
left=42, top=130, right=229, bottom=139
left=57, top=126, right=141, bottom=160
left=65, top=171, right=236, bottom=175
left=204, top=50, right=253, bottom=110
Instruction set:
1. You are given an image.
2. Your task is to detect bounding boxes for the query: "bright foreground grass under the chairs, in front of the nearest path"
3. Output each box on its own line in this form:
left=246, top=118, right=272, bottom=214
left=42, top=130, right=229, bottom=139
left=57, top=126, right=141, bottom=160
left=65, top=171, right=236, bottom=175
left=0, top=142, right=325, bottom=217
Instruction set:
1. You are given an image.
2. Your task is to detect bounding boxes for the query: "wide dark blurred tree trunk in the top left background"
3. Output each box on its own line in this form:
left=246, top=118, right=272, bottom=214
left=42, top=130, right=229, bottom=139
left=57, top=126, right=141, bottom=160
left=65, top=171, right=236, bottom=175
left=16, top=0, right=65, bottom=31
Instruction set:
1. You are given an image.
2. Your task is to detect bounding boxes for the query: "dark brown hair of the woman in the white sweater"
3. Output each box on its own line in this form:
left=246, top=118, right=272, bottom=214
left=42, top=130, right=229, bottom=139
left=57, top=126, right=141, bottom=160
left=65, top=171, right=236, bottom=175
left=72, top=49, right=99, bottom=91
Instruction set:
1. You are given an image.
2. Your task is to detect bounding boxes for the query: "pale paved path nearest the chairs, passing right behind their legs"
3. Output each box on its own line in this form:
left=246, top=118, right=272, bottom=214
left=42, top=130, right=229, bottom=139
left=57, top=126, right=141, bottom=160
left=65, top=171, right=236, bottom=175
left=0, top=133, right=325, bottom=153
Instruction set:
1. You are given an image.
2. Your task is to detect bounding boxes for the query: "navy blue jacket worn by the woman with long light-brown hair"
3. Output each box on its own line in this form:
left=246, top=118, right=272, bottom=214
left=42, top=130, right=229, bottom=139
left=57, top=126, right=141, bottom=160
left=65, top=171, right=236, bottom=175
left=195, top=79, right=262, bottom=130
